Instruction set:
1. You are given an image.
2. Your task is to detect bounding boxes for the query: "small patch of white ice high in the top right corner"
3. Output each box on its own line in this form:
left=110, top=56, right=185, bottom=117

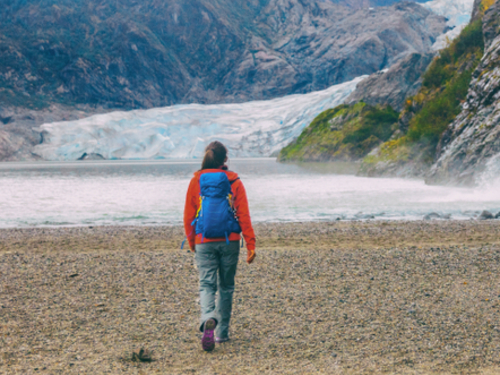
left=421, top=0, right=474, bottom=51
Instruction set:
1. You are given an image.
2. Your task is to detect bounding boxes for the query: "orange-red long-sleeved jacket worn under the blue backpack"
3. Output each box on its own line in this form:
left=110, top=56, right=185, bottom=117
left=184, top=169, right=255, bottom=250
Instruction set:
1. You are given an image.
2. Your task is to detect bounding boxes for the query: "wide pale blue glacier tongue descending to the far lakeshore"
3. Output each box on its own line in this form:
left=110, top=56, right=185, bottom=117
left=34, top=76, right=366, bottom=161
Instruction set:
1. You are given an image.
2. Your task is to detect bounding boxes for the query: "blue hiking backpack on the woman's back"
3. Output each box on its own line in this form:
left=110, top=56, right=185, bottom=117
left=192, top=172, right=241, bottom=243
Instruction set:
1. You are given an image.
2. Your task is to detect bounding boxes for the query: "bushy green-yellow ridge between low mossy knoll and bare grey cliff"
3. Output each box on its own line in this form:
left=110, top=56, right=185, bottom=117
left=360, top=0, right=488, bottom=184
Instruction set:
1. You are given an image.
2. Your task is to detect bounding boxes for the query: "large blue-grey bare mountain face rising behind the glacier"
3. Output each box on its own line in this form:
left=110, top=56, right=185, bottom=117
left=0, top=0, right=445, bottom=109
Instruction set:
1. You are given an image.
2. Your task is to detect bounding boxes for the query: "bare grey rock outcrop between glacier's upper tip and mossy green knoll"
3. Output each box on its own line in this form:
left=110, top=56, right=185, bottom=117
left=346, top=53, right=434, bottom=111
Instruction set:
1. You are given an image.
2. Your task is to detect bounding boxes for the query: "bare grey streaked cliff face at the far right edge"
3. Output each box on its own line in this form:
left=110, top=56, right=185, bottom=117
left=426, top=1, right=500, bottom=185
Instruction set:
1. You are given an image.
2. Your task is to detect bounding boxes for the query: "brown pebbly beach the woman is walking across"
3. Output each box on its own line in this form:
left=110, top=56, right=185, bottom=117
left=0, top=220, right=500, bottom=374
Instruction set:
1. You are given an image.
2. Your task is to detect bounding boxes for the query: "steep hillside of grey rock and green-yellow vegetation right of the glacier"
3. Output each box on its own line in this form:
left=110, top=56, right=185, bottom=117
left=280, top=0, right=500, bottom=185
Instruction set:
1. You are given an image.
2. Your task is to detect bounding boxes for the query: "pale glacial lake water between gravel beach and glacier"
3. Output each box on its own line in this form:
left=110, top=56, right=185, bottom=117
left=0, top=159, right=500, bottom=228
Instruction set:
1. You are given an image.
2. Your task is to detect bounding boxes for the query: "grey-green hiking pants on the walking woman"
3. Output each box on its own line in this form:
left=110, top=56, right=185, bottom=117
left=195, top=241, right=240, bottom=338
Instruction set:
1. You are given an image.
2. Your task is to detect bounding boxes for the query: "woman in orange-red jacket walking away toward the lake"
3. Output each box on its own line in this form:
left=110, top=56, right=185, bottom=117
left=184, top=141, right=255, bottom=351
